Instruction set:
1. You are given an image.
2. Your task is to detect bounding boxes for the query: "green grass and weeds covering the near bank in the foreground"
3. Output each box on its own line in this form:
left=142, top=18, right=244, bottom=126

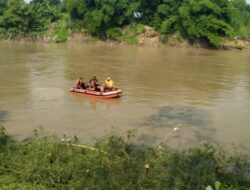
left=0, top=125, right=250, bottom=190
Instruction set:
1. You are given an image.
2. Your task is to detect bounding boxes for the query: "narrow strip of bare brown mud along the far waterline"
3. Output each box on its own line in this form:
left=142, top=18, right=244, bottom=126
left=0, top=30, right=250, bottom=50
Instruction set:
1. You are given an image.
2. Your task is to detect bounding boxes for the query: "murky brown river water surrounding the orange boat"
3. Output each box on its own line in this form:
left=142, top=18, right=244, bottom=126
left=0, top=42, right=250, bottom=150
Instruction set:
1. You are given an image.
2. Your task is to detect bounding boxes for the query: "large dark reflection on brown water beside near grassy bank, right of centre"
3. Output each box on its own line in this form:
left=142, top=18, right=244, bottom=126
left=136, top=106, right=215, bottom=149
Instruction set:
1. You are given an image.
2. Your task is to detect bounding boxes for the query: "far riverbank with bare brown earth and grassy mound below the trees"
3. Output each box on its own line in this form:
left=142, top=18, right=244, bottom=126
left=2, top=25, right=250, bottom=50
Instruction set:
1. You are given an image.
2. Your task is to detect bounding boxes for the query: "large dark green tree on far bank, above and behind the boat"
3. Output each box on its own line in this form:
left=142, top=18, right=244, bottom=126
left=65, top=0, right=130, bottom=38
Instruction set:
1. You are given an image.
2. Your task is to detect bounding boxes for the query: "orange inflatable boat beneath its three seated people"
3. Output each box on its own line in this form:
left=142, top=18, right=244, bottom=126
left=70, top=88, right=122, bottom=99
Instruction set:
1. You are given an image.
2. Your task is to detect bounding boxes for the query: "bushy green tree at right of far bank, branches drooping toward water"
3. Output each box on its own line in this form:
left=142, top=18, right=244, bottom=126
left=179, top=0, right=234, bottom=46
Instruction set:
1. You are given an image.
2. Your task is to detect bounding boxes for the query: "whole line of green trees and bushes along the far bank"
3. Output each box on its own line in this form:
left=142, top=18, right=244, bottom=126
left=0, top=0, right=250, bottom=46
